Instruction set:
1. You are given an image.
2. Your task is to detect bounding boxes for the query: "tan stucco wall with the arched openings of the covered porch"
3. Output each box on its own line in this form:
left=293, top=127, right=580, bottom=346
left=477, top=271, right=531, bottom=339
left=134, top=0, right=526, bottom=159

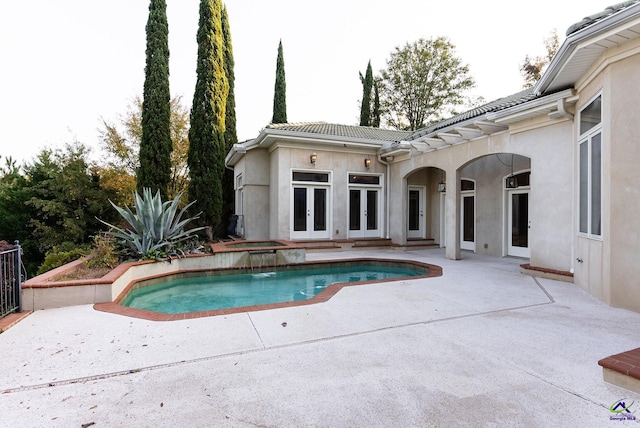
left=390, top=122, right=573, bottom=271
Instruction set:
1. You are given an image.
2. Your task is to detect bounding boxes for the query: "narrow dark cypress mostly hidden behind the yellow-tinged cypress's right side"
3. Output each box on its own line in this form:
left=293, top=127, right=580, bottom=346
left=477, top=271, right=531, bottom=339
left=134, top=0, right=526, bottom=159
left=222, top=6, right=238, bottom=224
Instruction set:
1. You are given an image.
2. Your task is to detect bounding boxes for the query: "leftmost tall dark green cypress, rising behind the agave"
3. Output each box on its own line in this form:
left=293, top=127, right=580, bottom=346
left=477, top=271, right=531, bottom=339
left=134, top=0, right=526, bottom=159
left=136, top=0, right=173, bottom=198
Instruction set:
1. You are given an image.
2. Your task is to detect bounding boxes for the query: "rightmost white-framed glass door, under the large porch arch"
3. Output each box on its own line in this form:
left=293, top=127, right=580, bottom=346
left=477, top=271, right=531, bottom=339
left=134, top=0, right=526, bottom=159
left=507, top=190, right=530, bottom=257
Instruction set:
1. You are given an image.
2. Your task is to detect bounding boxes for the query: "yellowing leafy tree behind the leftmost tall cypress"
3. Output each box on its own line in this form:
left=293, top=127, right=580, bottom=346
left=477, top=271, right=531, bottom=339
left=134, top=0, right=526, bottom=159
left=99, top=95, right=189, bottom=205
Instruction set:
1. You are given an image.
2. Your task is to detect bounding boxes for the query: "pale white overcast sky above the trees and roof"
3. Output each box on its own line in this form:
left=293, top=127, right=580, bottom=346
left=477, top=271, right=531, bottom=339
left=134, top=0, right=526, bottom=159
left=0, top=0, right=608, bottom=164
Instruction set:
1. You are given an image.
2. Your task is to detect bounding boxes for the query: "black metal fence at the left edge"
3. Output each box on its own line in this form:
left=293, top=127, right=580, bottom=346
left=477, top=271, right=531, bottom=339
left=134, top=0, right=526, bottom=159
left=0, top=242, right=22, bottom=318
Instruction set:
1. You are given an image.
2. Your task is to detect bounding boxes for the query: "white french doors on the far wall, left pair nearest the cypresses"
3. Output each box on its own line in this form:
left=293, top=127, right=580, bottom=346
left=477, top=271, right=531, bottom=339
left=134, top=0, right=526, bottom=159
left=291, top=185, right=329, bottom=239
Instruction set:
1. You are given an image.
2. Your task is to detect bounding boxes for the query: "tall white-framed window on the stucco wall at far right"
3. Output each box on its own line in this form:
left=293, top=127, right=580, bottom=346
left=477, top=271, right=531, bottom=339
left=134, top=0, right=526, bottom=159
left=578, top=95, right=602, bottom=237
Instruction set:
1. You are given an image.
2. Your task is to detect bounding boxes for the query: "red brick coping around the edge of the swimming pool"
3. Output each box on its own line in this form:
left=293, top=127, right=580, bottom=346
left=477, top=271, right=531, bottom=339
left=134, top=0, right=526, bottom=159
left=93, top=257, right=442, bottom=321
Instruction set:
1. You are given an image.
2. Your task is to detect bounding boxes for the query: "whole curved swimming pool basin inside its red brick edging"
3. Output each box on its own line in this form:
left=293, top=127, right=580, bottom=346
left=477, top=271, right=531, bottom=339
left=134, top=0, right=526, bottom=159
left=119, top=259, right=432, bottom=315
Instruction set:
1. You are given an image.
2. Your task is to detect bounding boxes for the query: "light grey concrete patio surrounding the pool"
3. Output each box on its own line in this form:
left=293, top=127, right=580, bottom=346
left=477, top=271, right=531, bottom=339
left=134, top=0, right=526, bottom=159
left=0, top=249, right=640, bottom=427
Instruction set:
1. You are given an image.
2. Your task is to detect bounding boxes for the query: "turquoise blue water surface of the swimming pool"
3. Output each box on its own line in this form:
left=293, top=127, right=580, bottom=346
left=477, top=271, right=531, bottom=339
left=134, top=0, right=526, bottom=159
left=121, top=265, right=425, bottom=314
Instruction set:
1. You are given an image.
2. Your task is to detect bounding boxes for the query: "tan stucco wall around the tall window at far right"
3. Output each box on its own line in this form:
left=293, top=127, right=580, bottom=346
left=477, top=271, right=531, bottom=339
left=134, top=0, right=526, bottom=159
left=574, top=40, right=640, bottom=311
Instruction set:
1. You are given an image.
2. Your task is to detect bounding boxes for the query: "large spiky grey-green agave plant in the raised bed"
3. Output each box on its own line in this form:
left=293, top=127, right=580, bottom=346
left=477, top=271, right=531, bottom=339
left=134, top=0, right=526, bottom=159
left=98, top=187, right=204, bottom=258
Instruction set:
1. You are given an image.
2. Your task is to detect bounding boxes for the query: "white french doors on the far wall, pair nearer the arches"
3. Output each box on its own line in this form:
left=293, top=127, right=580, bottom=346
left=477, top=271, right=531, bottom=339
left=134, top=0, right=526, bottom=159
left=349, top=187, right=381, bottom=238
